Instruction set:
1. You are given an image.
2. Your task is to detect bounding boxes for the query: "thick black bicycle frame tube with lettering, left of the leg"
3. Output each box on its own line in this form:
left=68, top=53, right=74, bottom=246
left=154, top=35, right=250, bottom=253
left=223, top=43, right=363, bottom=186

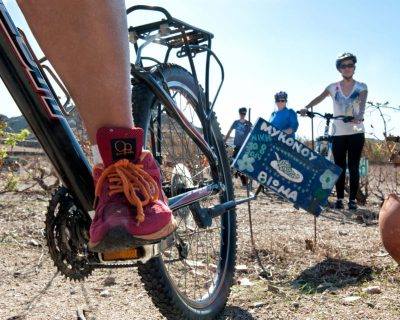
left=0, top=0, right=94, bottom=211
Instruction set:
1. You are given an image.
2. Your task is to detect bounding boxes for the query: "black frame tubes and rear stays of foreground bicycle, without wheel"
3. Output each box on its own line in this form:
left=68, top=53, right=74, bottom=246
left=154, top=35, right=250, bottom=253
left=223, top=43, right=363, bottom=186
left=0, top=0, right=223, bottom=212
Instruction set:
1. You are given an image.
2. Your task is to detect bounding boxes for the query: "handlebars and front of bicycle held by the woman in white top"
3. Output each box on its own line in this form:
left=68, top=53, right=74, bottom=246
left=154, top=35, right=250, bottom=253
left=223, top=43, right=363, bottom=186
left=297, top=111, right=354, bottom=162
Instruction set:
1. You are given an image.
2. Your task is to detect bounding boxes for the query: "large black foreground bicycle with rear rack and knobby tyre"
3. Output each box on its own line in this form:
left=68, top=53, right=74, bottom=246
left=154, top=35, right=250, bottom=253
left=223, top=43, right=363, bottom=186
left=0, top=5, right=252, bottom=319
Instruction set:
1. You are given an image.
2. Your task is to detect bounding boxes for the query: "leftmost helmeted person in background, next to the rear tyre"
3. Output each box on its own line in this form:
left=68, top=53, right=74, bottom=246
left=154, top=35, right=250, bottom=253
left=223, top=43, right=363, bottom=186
left=225, top=107, right=253, bottom=186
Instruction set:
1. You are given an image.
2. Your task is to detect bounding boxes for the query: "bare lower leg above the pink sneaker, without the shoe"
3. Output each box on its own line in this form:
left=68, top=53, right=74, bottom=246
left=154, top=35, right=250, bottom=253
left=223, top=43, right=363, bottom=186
left=18, top=0, right=133, bottom=144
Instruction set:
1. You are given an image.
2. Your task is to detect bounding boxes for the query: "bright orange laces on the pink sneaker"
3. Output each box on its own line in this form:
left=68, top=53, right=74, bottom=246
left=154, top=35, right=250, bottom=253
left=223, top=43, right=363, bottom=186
left=95, top=159, right=159, bottom=223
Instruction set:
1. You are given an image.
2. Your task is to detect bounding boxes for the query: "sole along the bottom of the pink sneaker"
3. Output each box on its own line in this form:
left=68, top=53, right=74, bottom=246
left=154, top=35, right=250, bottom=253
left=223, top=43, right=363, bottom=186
left=88, top=218, right=177, bottom=252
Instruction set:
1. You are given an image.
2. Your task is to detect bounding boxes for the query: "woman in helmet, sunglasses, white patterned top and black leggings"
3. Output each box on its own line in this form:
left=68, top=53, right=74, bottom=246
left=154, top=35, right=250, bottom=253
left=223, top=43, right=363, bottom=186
left=300, top=53, right=368, bottom=210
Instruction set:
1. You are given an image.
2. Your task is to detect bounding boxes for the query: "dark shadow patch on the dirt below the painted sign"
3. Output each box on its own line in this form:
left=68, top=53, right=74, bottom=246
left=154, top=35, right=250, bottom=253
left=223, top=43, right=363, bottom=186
left=292, top=258, right=373, bottom=294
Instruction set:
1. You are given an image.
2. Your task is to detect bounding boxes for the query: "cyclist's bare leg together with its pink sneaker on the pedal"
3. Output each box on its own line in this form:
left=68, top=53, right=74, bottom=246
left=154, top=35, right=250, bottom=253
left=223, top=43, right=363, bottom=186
left=19, top=0, right=176, bottom=252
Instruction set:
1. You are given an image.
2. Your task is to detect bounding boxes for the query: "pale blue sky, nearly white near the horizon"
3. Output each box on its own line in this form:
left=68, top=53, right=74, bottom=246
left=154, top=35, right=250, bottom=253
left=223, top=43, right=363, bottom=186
left=0, top=0, right=400, bottom=137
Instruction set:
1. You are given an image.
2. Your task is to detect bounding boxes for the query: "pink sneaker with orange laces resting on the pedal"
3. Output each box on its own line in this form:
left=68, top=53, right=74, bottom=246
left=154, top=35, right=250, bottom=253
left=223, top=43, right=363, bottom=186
left=89, top=128, right=176, bottom=252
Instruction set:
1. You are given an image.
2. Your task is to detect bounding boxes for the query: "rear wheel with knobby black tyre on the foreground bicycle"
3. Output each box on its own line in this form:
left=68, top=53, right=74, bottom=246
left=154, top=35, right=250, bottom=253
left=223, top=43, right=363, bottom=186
left=132, top=64, right=236, bottom=319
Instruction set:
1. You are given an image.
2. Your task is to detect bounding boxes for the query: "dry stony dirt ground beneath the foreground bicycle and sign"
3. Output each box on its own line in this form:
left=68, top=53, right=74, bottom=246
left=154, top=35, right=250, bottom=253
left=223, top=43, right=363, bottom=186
left=0, top=181, right=400, bottom=320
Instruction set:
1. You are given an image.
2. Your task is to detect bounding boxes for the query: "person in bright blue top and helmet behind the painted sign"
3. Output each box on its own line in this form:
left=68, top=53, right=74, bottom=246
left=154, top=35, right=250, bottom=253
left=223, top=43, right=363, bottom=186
left=269, top=91, right=299, bottom=137
